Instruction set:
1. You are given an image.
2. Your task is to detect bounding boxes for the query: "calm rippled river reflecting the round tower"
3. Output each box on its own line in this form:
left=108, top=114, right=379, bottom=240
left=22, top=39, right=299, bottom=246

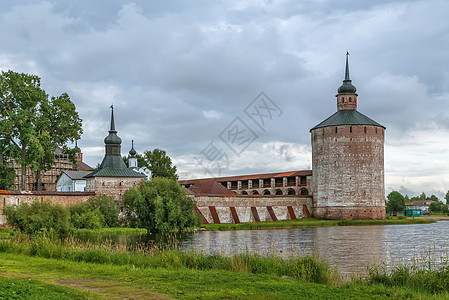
left=78, top=221, right=449, bottom=274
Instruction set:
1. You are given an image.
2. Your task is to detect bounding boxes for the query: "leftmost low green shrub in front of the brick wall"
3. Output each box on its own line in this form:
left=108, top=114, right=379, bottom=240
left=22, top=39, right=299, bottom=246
left=3, top=200, right=70, bottom=235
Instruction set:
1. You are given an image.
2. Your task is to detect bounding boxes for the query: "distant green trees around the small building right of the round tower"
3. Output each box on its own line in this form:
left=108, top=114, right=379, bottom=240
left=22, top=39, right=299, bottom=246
left=386, top=191, right=449, bottom=214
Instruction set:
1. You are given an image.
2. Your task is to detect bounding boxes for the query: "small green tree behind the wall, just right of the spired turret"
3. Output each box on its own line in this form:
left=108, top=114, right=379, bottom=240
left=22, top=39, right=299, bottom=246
left=144, top=148, right=178, bottom=180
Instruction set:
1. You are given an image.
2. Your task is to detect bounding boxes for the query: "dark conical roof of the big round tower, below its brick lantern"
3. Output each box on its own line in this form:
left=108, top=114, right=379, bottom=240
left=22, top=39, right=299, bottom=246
left=310, top=109, right=385, bottom=131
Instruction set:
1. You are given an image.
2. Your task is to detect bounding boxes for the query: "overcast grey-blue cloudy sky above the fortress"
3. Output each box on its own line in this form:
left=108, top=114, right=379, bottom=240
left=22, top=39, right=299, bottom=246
left=0, top=0, right=449, bottom=198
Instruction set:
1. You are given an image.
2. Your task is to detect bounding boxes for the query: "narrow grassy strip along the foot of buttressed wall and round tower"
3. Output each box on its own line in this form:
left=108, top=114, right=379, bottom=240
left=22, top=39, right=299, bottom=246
left=201, top=217, right=438, bottom=230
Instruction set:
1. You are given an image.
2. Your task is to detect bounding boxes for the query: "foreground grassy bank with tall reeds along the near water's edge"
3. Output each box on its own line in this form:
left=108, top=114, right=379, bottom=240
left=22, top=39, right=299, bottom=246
left=0, top=236, right=449, bottom=299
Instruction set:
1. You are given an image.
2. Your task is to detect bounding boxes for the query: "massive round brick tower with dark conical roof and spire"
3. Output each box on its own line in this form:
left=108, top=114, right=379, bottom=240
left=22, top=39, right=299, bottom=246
left=310, top=53, right=386, bottom=219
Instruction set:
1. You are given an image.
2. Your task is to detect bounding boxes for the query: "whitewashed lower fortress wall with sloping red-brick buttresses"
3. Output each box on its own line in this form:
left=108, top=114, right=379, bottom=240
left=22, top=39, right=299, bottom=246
left=194, top=195, right=312, bottom=223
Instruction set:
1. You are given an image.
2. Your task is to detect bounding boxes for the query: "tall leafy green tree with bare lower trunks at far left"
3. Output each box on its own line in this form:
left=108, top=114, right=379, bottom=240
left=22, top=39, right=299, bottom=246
left=0, top=71, right=82, bottom=189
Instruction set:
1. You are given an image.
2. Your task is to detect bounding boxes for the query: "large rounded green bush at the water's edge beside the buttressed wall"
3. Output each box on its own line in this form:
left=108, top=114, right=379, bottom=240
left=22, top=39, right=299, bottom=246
left=122, top=177, right=199, bottom=232
